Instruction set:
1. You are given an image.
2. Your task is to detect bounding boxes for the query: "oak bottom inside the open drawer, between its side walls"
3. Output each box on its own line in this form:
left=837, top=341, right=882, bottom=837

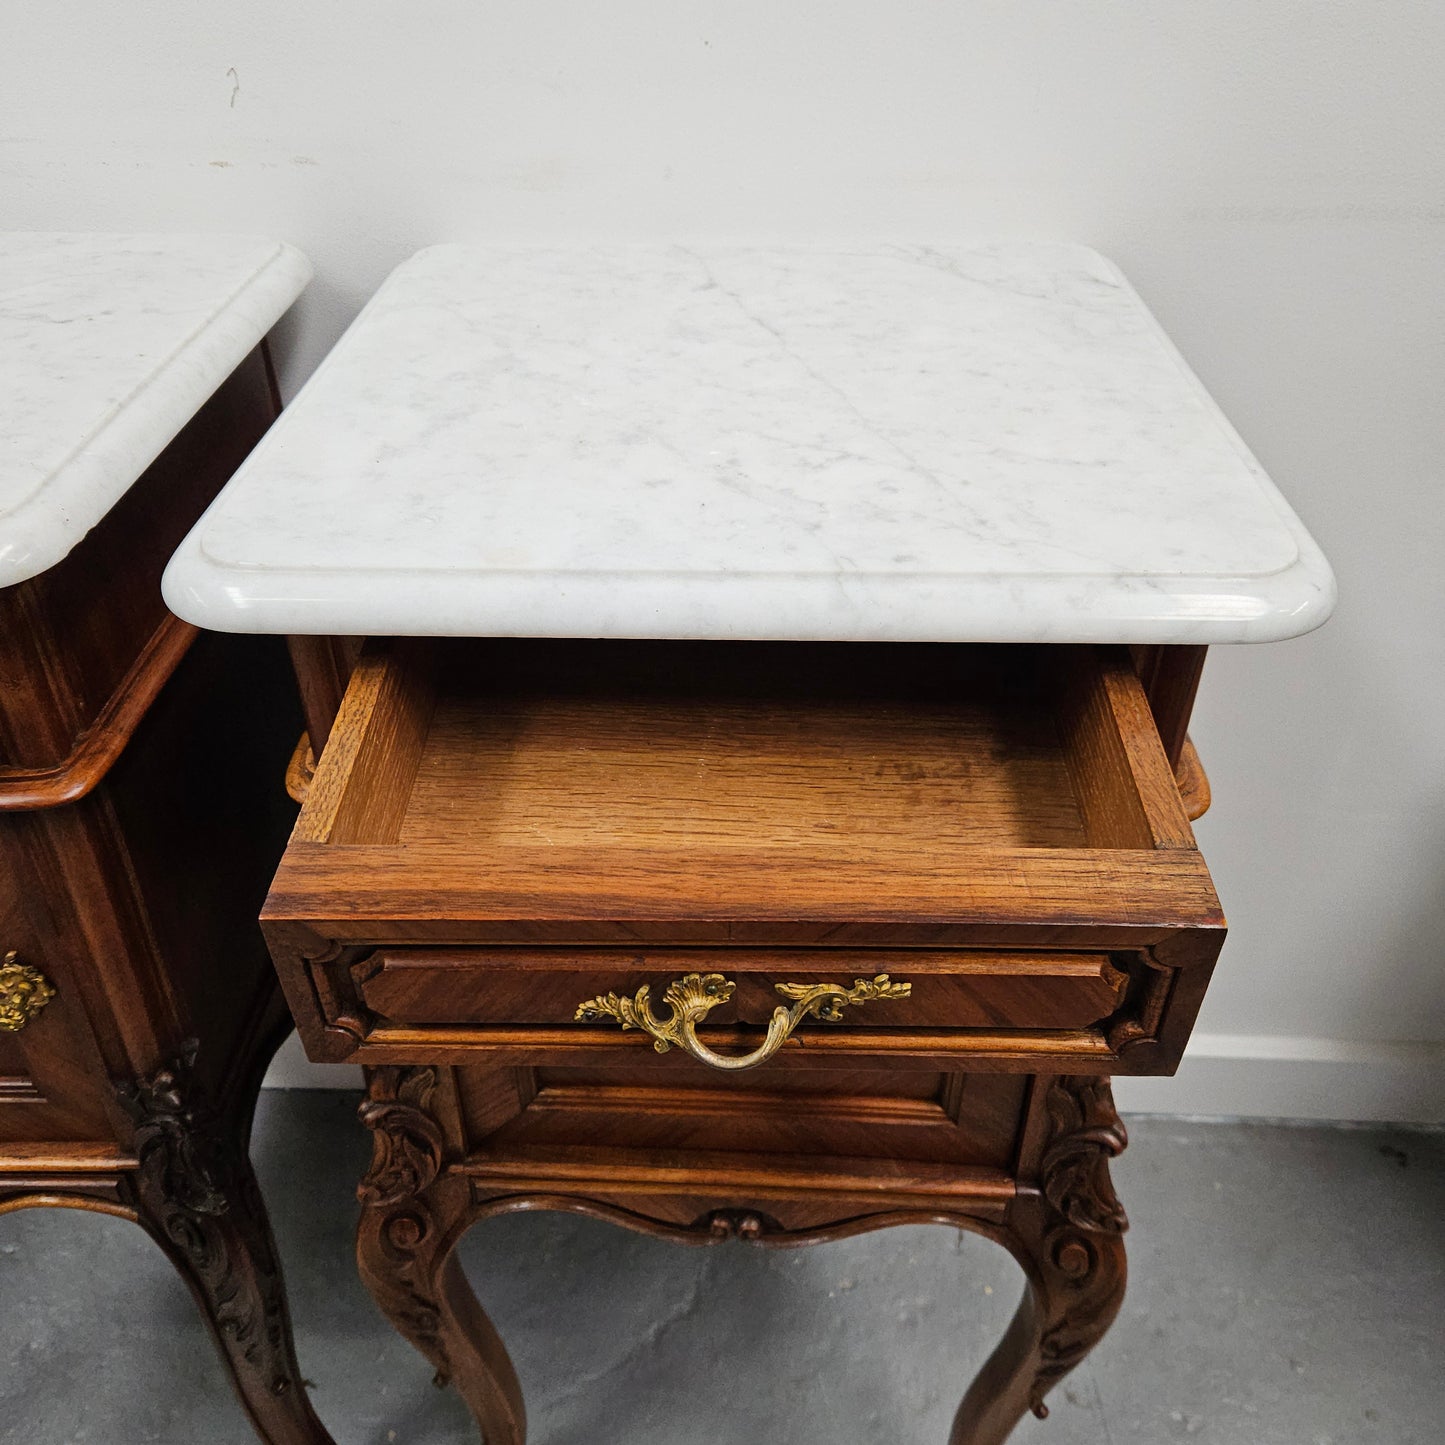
left=397, top=643, right=1088, bottom=849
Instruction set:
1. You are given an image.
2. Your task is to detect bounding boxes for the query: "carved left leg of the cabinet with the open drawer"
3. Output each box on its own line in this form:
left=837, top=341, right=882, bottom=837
left=357, top=1066, right=526, bottom=1445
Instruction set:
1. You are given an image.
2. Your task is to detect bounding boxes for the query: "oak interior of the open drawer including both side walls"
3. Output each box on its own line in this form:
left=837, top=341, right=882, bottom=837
left=296, top=642, right=1194, bottom=886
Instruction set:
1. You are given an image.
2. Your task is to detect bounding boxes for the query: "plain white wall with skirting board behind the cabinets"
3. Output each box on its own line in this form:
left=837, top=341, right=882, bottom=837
left=0, top=0, right=1445, bottom=1118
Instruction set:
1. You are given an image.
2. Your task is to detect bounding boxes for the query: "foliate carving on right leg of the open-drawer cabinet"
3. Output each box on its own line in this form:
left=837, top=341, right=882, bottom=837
left=1029, top=1075, right=1129, bottom=1419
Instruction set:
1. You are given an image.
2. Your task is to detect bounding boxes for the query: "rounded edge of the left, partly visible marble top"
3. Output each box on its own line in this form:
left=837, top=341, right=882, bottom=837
left=0, top=241, right=312, bottom=587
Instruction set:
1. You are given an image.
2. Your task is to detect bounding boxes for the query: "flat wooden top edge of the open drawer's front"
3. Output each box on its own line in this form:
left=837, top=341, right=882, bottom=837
left=262, top=838, right=1224, bottom=948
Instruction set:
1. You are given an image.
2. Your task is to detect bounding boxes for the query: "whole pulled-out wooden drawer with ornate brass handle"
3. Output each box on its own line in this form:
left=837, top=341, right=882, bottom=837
left=263, top=640, right=1224, bottom=1072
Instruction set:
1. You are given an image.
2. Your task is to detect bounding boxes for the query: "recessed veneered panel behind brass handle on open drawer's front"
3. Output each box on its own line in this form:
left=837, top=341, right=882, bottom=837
left=353, top=948, right=1127, bottom=1030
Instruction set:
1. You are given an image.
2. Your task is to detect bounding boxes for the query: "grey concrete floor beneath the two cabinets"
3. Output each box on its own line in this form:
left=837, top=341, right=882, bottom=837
left=0, top=1092, right=1445, bottom=1445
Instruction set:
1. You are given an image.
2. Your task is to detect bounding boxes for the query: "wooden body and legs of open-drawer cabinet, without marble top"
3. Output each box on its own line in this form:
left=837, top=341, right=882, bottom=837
left=264, top=642, right=1224, bottom=1442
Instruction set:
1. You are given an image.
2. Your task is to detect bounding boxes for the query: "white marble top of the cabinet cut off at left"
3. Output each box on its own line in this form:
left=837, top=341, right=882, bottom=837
left=0, top=233, right=311, bottom=587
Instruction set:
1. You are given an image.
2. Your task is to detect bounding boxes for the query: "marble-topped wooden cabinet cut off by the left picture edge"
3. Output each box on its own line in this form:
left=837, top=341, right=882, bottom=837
left=0, top=236, right=329, bottom=1445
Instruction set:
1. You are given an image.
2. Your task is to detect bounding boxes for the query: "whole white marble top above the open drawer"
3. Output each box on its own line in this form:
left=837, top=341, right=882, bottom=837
left=166, top=244, right=1334, bottom=643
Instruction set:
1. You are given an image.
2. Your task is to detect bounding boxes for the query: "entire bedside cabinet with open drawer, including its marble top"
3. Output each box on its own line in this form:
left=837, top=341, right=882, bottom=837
left=168, top=246, right=1332, bottom=1445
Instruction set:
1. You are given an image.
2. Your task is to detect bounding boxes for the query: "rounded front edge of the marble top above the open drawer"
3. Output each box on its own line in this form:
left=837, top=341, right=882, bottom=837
left=162, top=543, right=1335, bottom=644
